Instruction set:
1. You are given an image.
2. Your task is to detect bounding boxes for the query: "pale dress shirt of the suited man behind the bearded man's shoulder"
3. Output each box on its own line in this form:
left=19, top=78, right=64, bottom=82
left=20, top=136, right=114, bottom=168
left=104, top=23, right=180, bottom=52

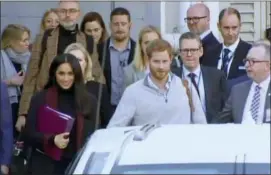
left=183, top=66, right=206, bottom=113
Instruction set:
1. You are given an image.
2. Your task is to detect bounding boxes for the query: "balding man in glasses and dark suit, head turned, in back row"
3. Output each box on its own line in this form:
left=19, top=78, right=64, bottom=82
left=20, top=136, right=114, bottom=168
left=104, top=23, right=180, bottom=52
left=185, top=3, right=222, bottom=62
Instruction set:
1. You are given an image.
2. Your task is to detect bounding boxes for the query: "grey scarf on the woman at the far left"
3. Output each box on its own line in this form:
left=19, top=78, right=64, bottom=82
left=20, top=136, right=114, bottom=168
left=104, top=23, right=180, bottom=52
left=1, top=48, right=31, bottom=104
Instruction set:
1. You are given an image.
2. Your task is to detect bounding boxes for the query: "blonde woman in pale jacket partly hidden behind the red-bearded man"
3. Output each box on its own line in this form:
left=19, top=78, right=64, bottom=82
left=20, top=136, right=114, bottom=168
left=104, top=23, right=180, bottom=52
left=124, top=25, right=161, bottom=87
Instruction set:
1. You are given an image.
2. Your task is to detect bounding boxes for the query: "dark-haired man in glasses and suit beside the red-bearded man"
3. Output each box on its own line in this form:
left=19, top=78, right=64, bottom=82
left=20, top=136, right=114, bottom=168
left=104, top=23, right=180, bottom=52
left=172, top=32, right=227, bottom=123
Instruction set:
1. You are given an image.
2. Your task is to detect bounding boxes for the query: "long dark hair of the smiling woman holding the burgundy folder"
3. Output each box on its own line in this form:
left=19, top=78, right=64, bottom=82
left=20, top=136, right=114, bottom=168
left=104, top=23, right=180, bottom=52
left=45, top=54, right=91, bottom=115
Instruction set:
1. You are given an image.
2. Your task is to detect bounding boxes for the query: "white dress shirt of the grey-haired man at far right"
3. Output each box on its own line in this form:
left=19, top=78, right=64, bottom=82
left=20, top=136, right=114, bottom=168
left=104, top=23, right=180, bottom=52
left=242, top=76, right=270, bottom=124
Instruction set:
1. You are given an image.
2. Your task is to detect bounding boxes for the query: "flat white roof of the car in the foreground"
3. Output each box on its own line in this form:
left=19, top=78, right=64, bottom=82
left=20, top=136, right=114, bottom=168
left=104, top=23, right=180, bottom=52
left=119, top=125, right=270, bottom=165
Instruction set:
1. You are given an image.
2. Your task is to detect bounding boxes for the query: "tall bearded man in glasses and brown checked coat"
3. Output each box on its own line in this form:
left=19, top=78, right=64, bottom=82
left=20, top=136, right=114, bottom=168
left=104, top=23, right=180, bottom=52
left=16, top=0, right=105, bottom=131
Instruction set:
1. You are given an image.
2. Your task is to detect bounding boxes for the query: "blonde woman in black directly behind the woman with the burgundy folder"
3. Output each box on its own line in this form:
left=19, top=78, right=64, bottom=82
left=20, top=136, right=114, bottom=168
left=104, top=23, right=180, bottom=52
left=64, top=43, right=112, bottom=128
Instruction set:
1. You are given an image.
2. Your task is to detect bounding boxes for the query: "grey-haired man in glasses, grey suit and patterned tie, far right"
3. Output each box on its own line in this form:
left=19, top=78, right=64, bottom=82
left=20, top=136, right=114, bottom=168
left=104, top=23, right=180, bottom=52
left=214, top=42, right=271, bottom=124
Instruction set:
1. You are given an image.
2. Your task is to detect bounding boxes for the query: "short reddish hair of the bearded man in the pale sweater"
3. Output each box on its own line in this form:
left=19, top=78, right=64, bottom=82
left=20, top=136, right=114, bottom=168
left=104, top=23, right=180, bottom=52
left=146, top=39, right=173, bottom=59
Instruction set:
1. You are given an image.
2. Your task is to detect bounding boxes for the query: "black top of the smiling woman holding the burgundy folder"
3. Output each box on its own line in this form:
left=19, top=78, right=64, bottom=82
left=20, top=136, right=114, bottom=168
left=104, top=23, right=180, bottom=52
left=25, top=85, right=97, bottom=158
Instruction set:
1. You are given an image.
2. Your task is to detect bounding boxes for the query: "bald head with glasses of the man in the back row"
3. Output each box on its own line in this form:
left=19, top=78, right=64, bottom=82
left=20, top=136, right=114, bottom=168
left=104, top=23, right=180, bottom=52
left=186, top=3, right=210, bottom=35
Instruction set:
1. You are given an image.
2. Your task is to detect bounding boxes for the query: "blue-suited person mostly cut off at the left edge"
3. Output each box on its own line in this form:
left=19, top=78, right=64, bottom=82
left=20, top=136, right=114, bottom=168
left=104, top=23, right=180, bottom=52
left=0, top=82, right=13, bottom=174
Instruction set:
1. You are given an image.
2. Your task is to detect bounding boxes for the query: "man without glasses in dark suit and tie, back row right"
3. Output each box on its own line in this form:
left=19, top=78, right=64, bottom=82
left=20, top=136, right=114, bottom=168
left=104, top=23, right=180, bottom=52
left=202, top=7, right=251, bottom=79
